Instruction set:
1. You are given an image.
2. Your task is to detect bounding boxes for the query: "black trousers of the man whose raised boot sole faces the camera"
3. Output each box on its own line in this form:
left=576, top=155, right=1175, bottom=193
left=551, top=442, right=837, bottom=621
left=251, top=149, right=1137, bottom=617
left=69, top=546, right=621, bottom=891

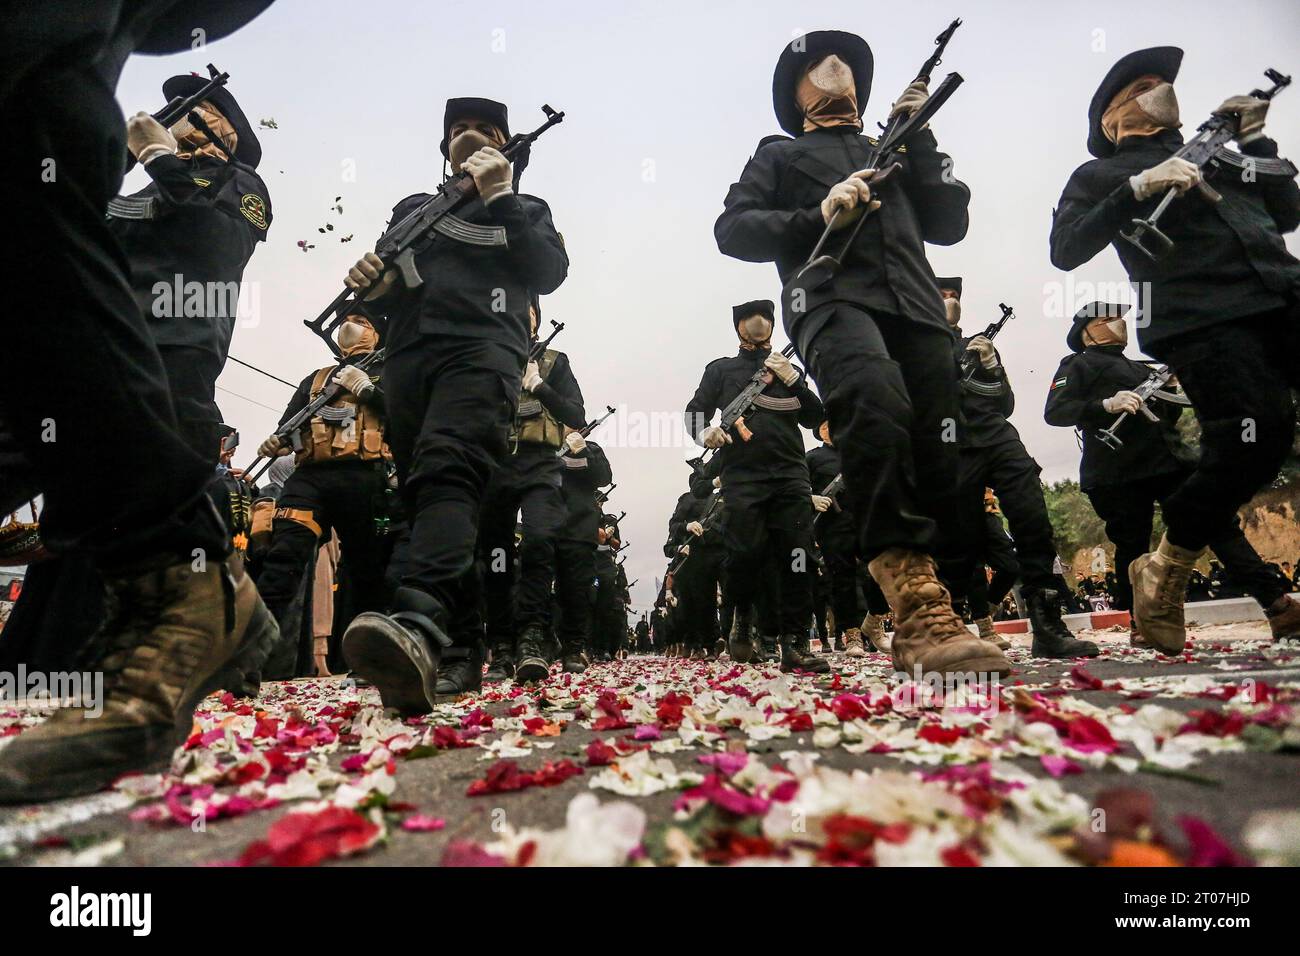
left=384, top=336, right=523, bottom=618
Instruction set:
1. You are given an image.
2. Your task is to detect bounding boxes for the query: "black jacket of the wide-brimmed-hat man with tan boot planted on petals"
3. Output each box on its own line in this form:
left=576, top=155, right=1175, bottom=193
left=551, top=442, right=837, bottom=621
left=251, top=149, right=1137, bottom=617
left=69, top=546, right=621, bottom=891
left=714, top=126, right=970, bottom=355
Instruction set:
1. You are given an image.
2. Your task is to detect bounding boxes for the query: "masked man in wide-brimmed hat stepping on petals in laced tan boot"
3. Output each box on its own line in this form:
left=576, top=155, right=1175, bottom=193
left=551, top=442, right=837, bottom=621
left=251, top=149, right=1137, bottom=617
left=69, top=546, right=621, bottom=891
left=714, top=31, right=1010, bottom=674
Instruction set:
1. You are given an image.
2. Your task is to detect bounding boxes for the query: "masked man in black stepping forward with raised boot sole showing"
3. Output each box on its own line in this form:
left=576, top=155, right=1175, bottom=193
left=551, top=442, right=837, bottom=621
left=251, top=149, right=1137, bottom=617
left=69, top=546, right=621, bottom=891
left=343, top=98, right=568, bottom=714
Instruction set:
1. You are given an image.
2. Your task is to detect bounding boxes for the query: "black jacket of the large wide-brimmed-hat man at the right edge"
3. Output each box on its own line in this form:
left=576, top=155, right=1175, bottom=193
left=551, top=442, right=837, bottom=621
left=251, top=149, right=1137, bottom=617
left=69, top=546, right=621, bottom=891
left=1052, top=130, right=1300, bottom=355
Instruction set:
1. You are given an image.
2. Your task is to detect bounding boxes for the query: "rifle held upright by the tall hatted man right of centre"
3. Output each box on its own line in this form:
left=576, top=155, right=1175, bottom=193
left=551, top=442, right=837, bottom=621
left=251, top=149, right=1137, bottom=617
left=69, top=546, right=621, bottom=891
left=781, top=20, right=963, bottom=295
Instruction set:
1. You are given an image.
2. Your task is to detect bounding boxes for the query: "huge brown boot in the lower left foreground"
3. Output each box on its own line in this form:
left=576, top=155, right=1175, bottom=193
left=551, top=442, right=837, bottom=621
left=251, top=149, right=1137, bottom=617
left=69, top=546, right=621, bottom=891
left=0, top=557, right=280, bottom=804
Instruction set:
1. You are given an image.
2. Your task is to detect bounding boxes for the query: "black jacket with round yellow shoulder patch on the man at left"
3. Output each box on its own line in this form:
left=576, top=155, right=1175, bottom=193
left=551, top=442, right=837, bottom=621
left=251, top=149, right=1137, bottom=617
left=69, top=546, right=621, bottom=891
left=108, top=156, right=270, bottom=363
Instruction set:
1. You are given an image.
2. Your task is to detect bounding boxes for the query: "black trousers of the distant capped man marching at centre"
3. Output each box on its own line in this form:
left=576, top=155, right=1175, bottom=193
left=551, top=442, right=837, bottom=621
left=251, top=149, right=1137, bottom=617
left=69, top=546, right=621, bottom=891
left=722, top=481, right=813, bottom=639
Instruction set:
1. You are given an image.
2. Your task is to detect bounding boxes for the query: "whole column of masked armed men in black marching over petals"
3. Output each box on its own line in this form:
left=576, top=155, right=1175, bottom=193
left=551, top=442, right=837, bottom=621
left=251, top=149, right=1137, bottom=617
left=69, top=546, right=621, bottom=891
left=0, top=0, right=1300, bottom=803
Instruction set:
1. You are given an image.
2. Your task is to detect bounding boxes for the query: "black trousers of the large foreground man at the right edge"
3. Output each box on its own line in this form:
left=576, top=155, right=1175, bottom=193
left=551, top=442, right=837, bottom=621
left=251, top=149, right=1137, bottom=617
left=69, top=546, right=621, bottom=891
left=1147, top=306, right=1300, bottom=561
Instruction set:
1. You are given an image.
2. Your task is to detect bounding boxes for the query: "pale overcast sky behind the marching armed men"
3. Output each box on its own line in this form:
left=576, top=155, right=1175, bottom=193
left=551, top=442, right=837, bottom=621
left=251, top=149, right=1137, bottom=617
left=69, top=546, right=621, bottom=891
left=120, top=0, right=1300, bottom=609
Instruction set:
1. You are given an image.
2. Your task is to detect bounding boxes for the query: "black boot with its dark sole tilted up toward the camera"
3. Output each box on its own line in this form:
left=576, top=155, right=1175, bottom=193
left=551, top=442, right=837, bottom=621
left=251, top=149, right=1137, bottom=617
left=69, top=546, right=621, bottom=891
left=343, top=588, right=451, bottom=717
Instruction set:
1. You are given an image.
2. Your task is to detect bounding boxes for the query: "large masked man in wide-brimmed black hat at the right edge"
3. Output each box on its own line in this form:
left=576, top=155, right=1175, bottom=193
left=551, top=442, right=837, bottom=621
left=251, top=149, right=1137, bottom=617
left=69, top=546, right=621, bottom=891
left=1052, top=47, right=1300, bottom=653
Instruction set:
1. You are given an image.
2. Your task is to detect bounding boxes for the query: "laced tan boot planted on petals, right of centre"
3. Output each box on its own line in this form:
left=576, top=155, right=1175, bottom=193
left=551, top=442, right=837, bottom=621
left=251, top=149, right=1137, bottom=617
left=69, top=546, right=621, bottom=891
left=867, top=548, right=1011, bottom=675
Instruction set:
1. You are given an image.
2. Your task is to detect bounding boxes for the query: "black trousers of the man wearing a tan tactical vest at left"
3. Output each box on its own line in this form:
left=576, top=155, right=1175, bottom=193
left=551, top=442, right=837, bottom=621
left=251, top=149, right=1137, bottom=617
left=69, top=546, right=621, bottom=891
left=257, top=462, right=390, bottom=633
